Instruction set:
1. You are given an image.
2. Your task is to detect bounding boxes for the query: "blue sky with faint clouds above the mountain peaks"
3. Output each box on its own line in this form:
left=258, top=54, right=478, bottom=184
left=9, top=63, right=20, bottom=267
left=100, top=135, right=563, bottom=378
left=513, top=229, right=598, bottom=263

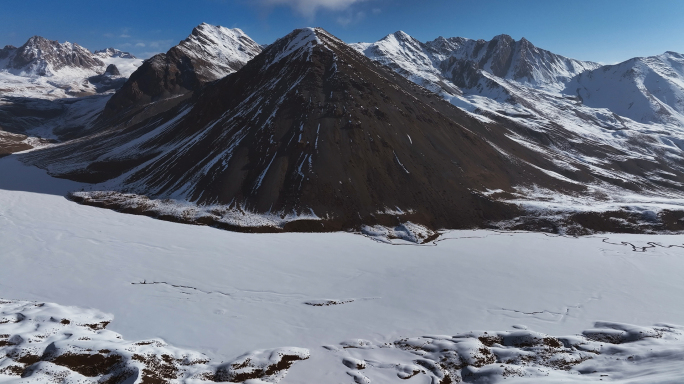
left=0, top=0, right=684, bottom=63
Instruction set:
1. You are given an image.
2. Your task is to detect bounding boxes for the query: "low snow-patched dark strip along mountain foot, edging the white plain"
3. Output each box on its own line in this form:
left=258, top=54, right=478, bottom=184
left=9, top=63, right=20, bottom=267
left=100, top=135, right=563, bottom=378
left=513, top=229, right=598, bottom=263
left=67, top=192, right=684, bottom=243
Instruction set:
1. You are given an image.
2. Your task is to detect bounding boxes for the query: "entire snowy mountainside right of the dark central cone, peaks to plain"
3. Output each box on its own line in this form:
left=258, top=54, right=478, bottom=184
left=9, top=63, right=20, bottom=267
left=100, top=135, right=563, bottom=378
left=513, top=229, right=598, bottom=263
left=355, top=33, right=684, bottom=225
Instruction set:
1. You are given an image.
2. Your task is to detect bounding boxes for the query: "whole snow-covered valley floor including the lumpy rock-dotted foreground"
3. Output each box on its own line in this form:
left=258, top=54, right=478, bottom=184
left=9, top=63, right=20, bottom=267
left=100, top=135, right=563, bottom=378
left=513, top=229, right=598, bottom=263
left=0, top=156, right=684, bottom=384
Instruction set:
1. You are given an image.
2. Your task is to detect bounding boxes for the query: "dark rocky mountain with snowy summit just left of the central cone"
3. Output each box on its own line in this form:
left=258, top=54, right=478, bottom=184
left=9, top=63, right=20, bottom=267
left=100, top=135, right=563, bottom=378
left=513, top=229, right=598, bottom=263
left=104, top=23, right=261, bottom=117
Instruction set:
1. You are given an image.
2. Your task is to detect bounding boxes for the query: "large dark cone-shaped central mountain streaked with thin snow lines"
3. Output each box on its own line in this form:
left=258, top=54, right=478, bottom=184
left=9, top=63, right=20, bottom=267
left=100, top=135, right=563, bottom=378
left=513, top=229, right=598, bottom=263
left=22, top=29, right=577, bottom=230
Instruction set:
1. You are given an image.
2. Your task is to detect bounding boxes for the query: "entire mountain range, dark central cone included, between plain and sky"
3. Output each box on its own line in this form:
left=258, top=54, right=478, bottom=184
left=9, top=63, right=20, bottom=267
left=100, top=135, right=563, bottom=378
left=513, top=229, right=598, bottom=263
left=0, top=24, right=684, bottom=240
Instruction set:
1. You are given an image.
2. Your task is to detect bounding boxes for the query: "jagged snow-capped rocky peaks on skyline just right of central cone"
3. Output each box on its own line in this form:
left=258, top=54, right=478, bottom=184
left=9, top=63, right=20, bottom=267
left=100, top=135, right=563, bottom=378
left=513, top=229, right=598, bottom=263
left=352, top=31, right=600, bottom=95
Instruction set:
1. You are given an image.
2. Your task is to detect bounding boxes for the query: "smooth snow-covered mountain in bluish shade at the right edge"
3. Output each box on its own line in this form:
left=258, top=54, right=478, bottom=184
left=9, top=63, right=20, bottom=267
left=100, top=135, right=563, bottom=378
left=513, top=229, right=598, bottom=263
left=565, top=52, right=684, bottom=127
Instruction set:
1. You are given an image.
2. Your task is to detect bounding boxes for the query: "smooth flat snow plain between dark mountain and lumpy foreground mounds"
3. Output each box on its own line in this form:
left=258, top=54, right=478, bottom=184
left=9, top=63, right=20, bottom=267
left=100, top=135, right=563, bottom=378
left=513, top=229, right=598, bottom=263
left=0, top=156, right=684, bottom=383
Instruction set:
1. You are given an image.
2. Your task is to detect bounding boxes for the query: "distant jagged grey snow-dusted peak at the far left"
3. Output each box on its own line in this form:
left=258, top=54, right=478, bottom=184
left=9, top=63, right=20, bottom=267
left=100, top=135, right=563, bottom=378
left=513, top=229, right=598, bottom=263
left=5, top=36, right=104, bottom=76
